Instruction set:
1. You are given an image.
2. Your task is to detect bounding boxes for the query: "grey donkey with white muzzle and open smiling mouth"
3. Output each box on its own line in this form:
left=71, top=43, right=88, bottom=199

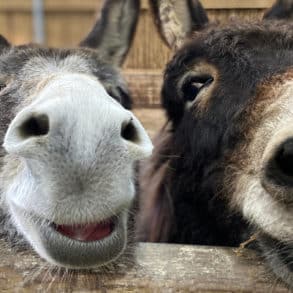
left=0, top=0, right=152, bottom=268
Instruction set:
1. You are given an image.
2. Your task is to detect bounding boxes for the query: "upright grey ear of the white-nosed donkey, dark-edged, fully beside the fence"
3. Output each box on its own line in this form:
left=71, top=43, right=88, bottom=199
left=80, top=0, right=140, bottom=66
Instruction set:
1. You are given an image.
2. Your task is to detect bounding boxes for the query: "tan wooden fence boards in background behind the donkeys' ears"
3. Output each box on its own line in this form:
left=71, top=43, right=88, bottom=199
left=0, top=0, right=273, bottom=69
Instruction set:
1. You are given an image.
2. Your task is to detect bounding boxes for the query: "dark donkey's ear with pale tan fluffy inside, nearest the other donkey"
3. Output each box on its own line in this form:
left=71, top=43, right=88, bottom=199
left=150, top=0, right=209, bottom=49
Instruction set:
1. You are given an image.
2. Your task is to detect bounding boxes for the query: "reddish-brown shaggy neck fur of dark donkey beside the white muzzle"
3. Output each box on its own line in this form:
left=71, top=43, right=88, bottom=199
left=137, top=125, right=173, bottom=242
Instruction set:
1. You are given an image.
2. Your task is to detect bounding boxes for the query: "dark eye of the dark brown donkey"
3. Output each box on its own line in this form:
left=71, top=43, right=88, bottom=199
left=182, top=75, right=214, bottom=102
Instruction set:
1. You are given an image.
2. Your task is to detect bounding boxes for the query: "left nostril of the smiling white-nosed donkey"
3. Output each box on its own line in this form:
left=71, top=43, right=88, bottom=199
left=19, top=114, right=49, bottom=138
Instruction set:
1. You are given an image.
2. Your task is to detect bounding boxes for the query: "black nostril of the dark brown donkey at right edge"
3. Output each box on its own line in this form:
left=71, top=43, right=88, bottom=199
left=275, top=140, right=293, bottom=178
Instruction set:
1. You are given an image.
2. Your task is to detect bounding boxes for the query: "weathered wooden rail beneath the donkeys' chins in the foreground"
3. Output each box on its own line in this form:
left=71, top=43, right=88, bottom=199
left=0, top=241, right=290, bottom=292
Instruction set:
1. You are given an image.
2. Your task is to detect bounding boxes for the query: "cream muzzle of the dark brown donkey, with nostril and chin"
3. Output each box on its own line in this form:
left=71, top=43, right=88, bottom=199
left=231, top=88, right=293, bottom=285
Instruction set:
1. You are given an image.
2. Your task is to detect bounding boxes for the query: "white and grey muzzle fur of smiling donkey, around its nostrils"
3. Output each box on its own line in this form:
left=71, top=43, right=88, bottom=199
left=4, top=74, right=152, bottom=262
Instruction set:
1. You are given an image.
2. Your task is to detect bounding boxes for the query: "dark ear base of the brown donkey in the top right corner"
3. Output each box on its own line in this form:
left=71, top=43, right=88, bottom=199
left=264, top=0, right=293, bottom=20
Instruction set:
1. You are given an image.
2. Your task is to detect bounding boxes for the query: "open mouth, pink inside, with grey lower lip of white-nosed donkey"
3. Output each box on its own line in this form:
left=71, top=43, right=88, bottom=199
left=10, top=197, right=129, bottom=269
